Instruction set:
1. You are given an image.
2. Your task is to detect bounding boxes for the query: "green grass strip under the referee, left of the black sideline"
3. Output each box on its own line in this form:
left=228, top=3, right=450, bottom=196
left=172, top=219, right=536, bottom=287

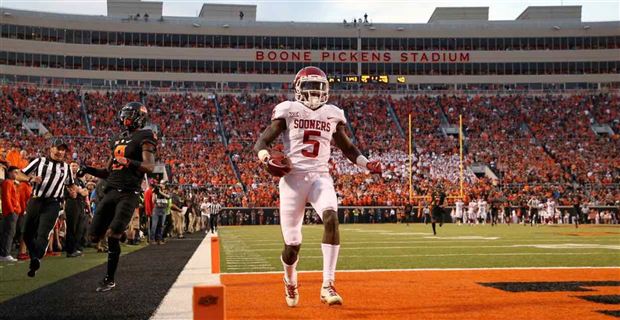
left=0, top=245, right=144, bottom=303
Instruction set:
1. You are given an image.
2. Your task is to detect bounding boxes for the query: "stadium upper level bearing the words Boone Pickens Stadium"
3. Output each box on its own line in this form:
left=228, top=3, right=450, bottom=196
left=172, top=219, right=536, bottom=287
left=0, top=0, right=620, bottom=89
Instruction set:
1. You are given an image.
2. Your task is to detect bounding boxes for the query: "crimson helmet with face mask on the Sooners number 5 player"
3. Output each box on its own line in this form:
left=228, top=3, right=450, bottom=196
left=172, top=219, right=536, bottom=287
left=293, top=67, right=329, bottom=110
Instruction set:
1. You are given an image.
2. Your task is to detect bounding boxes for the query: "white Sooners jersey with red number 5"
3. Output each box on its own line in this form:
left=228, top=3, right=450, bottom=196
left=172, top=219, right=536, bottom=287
left=271, top=101, right=347, bottom=173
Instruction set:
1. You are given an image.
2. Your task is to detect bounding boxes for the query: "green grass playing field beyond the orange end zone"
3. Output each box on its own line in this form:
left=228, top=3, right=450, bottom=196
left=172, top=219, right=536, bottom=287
left=219, top=224, right=620, bottom=273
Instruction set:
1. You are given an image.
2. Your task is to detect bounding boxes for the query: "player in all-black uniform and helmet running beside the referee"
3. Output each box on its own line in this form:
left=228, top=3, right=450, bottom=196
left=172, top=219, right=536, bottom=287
left=78, top=102, right=157, bottom=292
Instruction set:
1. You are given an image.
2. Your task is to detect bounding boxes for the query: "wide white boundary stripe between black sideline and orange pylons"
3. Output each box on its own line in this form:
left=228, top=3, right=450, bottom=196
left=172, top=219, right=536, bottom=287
left=151, top=235, right=220, bottom=320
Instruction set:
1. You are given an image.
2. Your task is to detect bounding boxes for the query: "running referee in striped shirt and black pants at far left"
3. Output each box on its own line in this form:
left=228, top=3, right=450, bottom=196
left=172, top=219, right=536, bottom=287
left=17, top=138, right=76, bottom=277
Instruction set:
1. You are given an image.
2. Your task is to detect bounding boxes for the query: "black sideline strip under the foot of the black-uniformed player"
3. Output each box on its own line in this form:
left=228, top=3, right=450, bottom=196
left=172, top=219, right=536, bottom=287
left=0, top=233, right=205, bottom=320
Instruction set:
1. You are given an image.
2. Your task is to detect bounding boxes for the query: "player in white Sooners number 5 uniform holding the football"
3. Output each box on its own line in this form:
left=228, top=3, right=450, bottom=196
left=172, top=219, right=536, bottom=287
left=254, top=67, right=381, bottom=307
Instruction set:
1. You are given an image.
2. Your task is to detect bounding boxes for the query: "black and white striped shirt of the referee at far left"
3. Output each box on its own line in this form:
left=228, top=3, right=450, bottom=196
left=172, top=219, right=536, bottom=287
left=22, top=157, right=74, bottom=199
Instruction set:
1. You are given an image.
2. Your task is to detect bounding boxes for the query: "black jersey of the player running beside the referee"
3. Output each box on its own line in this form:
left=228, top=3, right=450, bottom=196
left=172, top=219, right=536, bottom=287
left=107, top=129, right=157, bottom=191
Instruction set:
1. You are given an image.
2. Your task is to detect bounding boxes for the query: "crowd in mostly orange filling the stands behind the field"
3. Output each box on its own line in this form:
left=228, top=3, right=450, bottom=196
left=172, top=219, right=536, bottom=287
left=0, top=86, right=620, bottom=207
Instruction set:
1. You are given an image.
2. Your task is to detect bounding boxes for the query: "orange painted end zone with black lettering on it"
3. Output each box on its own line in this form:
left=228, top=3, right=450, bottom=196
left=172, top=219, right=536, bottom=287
left=222, top=268, right=620, bottom=320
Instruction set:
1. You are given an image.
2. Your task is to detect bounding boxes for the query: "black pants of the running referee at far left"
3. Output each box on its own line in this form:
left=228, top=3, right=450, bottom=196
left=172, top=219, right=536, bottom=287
left=23, top=197, right=60, bottom=259
